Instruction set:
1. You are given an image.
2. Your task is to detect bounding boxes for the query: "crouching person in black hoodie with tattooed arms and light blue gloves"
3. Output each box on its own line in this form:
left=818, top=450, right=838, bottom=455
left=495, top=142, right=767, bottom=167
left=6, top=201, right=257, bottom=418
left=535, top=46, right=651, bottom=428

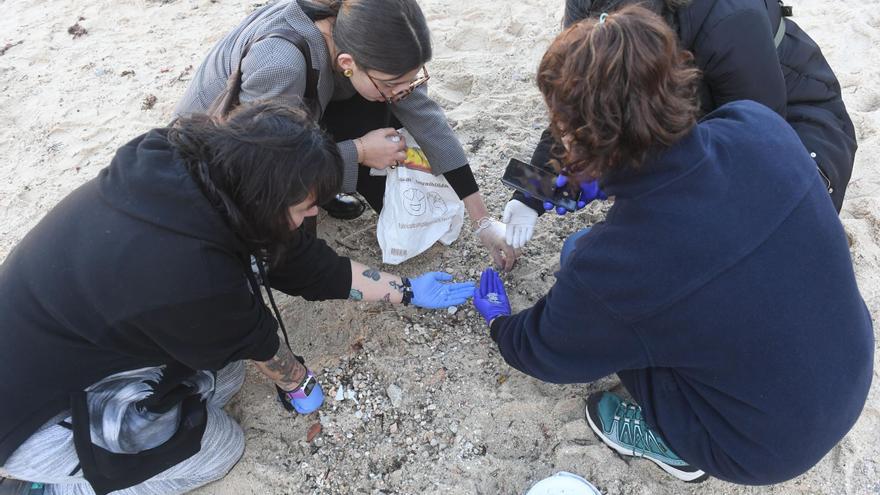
left=0, top=103, right=473, bottom=495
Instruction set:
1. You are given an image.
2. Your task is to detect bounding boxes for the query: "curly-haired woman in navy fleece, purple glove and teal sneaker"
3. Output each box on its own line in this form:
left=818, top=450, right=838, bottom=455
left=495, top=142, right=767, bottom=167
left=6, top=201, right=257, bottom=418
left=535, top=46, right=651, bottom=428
left=475, top=7, right=874, bottom=484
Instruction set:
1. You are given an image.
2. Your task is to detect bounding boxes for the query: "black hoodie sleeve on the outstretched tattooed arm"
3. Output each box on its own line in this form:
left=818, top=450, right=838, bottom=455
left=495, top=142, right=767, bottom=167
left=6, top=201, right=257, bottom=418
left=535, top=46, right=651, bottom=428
left=269, top=229, right=351, bottom=301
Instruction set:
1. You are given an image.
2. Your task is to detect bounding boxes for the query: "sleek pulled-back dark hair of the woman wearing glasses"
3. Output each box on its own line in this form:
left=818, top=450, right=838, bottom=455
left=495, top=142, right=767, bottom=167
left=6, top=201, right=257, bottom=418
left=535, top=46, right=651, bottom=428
left=297, top=0, right=432, bottom=76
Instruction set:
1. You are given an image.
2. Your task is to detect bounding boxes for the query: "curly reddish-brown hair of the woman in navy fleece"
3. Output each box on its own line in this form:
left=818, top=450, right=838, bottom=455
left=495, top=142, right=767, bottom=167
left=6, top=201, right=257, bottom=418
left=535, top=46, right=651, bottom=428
left=538, top=5, right=700, bottom=180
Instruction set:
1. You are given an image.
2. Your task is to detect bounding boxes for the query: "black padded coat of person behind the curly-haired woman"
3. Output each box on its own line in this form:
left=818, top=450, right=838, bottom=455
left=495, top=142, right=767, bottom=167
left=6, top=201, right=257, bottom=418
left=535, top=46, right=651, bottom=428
left=514, top=0, right=857, bottom=213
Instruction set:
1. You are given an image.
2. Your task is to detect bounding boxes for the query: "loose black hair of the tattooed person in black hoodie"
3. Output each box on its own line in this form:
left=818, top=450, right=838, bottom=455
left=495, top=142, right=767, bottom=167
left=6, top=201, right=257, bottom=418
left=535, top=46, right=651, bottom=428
left=168, top=102, right=343, bottom=262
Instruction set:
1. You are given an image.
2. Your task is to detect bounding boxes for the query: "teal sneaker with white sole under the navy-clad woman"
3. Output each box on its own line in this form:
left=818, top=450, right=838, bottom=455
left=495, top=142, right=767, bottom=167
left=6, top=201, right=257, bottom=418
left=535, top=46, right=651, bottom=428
left=587, top=392, right=708, bottom=482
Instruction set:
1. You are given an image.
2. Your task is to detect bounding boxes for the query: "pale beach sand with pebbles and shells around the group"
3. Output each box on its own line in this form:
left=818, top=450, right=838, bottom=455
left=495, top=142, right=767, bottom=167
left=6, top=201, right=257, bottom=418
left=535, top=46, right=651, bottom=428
left=0, top=0, right=880, bottom=495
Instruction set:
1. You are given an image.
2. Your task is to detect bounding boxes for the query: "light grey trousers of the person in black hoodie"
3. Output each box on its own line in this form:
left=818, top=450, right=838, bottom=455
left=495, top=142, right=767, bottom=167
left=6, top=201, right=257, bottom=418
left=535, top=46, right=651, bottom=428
left=3, top=361, right=244, bottom=495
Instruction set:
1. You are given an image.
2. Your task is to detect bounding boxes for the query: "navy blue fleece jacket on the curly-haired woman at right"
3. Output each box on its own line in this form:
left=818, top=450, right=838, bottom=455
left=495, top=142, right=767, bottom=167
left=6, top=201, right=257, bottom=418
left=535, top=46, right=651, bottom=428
left=492, top=101, right=874, bottom=484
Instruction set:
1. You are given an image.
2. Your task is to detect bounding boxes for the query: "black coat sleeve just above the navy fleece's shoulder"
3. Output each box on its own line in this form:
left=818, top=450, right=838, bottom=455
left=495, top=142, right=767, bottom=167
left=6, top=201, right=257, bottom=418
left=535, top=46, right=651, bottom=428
left=692, top=8, right=787, bottom=117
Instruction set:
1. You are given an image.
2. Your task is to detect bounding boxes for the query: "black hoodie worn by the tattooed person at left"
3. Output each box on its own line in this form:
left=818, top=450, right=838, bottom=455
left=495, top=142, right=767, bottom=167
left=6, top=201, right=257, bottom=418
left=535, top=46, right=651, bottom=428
left=0, top=130, right=351, bottom=465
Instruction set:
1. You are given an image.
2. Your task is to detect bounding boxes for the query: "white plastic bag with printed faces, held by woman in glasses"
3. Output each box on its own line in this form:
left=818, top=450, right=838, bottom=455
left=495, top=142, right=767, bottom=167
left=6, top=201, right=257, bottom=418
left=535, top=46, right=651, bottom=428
left=376, top=132, right=464, bottom=265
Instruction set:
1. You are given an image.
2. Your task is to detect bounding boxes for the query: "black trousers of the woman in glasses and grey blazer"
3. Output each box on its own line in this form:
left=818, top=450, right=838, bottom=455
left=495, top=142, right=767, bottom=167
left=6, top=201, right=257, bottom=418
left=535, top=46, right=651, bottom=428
left=321, top=93, right=403, bottom=213
